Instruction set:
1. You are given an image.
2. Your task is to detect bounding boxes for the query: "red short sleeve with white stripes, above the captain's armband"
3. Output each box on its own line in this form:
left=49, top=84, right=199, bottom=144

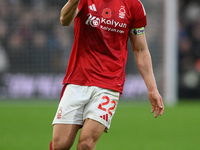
left=130, top=0, right=147, bottom=29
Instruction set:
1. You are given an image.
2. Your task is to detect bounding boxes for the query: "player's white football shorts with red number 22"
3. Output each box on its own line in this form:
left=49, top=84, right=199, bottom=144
left=53, top=84, right=120, bottom=130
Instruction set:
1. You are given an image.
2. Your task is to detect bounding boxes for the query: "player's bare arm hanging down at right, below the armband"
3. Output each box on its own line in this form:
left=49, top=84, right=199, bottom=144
left=130, top=29, right=164, bottom=118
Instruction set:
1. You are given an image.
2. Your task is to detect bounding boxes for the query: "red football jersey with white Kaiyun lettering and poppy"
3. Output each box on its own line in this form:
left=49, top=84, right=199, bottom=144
left=63, top=0, right=146, bottom=93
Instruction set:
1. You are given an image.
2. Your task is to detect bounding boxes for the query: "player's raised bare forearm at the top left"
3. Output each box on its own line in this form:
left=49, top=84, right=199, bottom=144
left=60, top=0, right=80, bottom=26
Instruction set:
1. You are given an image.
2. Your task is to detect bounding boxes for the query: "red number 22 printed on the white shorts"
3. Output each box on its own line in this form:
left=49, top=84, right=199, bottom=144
left=98, top=96, right=116, bottom=116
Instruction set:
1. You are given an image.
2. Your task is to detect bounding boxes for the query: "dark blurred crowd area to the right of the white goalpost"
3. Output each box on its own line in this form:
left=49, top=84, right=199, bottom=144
left=178, top=0, right=200, bottom=98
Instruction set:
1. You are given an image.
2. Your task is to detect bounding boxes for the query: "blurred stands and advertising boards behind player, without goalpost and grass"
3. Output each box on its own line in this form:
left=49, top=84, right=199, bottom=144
left=0, top=0, right=200, bottom=100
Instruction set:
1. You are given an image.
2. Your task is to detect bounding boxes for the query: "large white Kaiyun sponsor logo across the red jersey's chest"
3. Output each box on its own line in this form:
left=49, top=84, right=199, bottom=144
left=85, top=13, right=127, bottom=33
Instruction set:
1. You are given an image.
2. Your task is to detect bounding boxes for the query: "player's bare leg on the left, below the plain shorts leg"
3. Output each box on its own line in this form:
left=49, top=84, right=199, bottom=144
left=53, top=124, right=81, bottom=149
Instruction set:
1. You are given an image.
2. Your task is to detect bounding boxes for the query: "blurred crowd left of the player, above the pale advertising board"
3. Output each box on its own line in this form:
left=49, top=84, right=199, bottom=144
left=0, top=0, right=73, bottom=73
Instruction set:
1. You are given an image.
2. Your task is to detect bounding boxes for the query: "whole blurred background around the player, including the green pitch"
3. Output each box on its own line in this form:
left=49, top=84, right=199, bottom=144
left=0, top=0, right=200, bottom=150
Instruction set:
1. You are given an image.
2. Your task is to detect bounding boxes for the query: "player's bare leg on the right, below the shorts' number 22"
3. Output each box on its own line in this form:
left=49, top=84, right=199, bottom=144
left=77, top=119, right=106, bottom=150
